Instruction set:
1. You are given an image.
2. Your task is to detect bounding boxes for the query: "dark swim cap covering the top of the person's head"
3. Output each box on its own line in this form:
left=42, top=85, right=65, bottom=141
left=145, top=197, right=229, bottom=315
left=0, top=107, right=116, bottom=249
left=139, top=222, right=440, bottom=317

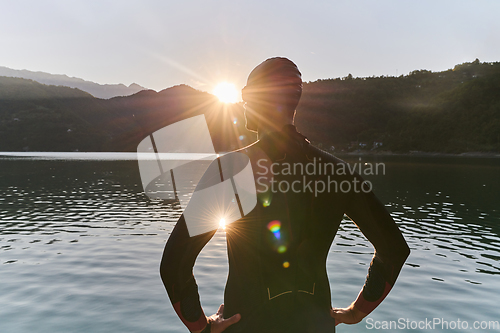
left=242, top=57, right=302, bottom=108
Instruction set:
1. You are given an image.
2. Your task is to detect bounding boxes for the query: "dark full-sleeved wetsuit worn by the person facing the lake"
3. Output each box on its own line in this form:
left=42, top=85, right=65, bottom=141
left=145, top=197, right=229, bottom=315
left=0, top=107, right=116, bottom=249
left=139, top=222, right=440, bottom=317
left=160, top=125, right=409, bottom=333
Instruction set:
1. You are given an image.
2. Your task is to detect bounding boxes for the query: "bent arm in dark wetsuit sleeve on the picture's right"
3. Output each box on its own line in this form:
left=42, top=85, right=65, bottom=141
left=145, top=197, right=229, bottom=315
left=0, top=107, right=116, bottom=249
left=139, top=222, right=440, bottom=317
left=332, top=178, right=410, bottom=323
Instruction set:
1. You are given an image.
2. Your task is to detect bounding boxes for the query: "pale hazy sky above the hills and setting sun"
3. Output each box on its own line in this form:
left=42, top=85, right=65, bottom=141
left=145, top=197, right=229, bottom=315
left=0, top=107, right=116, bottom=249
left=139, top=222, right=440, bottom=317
left=0, top=0, right=500, bottom=96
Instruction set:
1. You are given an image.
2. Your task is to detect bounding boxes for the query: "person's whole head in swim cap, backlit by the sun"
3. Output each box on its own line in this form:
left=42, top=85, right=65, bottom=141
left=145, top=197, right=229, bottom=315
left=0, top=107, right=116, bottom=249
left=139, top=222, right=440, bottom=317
left=242, top=58, right=302, bottom=131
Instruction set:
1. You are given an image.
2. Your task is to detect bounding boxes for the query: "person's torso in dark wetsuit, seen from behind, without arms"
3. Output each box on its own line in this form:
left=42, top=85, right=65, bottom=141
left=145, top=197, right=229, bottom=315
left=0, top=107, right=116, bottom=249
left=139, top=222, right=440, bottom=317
left=224, top=126, right=349, bottom=332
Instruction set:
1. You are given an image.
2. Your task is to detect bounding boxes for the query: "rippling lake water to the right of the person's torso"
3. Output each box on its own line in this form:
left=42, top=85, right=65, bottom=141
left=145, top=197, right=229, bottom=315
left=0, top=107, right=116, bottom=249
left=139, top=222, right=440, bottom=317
left=329, top=157, right=500, bottom=332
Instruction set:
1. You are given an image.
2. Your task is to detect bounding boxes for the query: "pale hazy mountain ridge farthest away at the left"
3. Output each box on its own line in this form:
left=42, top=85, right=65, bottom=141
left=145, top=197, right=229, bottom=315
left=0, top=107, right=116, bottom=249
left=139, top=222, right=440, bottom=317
left=0, top=66, right=146, bottom=99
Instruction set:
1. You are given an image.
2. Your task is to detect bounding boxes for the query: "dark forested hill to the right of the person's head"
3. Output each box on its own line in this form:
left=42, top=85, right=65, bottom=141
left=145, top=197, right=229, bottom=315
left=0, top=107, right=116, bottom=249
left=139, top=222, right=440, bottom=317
left=296, top=59, right=500, bottom=153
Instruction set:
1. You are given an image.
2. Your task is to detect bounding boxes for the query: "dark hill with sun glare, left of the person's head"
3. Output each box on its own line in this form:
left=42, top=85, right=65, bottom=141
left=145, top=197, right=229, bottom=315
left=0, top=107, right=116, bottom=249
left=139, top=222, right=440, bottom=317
left=0, top=77, right=255, bottom=151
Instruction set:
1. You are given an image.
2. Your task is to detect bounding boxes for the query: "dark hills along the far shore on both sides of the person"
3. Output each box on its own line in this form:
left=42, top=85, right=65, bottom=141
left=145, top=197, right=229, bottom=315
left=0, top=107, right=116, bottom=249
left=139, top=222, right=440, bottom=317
left=0, top=60, right=500, bottom=153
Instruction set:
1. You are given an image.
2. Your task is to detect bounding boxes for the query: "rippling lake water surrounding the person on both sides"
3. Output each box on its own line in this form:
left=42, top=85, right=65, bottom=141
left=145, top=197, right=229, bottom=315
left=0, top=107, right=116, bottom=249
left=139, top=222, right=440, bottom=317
left=0, top=154, right=500, bottom=333
